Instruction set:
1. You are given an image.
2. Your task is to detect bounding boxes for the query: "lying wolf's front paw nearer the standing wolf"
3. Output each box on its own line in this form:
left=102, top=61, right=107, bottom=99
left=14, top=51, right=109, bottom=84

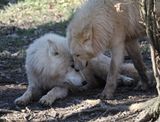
left=39, top=95, right=55, bottom=106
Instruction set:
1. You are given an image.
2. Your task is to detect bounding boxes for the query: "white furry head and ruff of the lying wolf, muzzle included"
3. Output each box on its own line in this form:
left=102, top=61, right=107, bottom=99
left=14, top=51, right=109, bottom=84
left=26, top=33, right=86, bottom=87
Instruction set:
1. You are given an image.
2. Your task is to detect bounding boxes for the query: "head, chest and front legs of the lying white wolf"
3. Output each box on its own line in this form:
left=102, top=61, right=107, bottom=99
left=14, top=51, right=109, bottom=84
left=15, top=33, right=85, bottom=105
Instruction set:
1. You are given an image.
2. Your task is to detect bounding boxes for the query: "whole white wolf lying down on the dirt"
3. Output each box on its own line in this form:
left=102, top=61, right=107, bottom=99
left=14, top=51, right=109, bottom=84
left=15, top=33, right=152, bottom=105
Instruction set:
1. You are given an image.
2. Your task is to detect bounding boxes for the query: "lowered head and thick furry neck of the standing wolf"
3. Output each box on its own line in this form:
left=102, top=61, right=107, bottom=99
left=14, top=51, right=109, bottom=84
left=67, top=0, right=109, bottom=70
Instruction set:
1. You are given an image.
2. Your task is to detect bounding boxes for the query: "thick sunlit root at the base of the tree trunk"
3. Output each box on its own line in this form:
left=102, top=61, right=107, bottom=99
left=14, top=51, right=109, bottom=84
left=129, top=96, right=160, bottom=122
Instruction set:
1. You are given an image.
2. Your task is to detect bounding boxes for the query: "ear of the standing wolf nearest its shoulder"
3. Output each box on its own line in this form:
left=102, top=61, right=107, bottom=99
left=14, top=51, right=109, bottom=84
left=81, top=24, right=94, bottom=44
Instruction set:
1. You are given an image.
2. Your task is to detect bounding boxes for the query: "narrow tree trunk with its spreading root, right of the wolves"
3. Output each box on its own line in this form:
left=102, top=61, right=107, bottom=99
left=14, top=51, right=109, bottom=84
left=130, top=0, right=160, bottom=122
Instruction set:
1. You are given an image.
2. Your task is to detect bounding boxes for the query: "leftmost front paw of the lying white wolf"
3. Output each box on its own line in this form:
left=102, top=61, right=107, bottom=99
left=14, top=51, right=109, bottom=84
left=14, top=96, right=30, bottom=106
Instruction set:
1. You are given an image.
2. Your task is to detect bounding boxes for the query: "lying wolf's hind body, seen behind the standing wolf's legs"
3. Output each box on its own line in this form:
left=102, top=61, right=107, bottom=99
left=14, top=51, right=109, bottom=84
left=83, top=54, right=155, bottom=89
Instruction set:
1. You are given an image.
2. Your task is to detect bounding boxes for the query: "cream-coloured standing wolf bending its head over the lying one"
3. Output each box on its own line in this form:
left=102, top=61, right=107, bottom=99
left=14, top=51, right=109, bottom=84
left=67, top=0, right=148, bottom=99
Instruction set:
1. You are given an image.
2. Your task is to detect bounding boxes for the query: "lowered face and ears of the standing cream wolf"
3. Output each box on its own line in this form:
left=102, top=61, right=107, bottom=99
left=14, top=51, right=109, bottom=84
left=67, top=22, right=96, bottom=70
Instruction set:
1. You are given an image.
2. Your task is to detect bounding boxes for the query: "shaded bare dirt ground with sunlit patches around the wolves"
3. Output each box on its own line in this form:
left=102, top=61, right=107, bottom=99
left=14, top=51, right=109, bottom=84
left=0, top=14, right=156, bottom=122
